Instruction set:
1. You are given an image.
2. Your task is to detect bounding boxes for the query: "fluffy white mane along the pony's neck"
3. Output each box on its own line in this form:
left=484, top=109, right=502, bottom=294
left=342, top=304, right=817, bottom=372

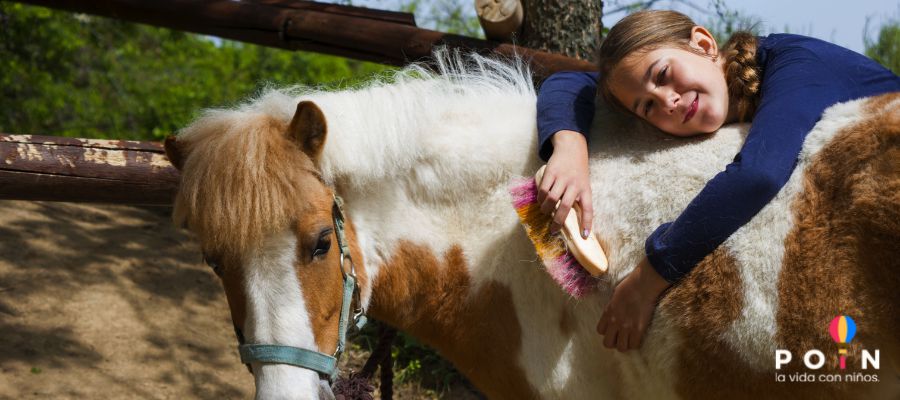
left=224, top=49, right=536, bottom=189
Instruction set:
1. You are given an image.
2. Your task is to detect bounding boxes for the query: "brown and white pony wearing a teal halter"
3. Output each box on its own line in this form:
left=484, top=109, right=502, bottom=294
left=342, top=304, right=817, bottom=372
left=166, top=50, right=900, bottom=399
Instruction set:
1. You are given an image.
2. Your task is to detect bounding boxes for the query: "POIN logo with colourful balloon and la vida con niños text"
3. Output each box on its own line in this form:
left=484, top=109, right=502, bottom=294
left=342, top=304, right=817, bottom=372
left=775, top=315, right=881, bottom=382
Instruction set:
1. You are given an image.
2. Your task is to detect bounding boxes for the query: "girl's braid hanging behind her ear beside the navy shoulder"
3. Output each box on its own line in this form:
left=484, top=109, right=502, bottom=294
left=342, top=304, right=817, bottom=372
left=724, top=31, right=762, bottom=122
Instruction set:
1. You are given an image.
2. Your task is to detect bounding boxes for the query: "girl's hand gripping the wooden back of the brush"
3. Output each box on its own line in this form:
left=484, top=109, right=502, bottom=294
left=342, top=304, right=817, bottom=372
left=537, top=130, right=594, bottom=238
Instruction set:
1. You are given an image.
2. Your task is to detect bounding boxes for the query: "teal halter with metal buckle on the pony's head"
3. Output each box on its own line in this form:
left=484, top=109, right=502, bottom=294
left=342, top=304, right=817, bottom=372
left=211, top=195, right=366, bottom=381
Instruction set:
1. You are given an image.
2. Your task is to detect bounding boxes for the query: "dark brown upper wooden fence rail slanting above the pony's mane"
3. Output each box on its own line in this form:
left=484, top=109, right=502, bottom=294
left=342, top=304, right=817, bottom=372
left=18, top=0, right=595, bottom=77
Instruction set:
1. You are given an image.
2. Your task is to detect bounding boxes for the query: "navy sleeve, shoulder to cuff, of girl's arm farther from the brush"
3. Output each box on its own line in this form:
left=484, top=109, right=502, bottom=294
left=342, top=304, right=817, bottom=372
left=645, top=49, right=861, bottom=283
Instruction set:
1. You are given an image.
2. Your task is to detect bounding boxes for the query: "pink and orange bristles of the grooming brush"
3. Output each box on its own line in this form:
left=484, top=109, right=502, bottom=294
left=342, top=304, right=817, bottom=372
left=509, top=178, right=598, bottom=298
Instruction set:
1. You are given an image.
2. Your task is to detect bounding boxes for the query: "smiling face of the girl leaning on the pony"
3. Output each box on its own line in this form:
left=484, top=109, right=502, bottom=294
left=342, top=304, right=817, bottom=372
left=610, top=26, right=733, bottom=136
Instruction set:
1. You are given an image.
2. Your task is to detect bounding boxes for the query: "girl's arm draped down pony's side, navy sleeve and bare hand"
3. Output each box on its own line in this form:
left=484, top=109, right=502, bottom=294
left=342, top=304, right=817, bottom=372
left=597, top=35, right=900, bottom=351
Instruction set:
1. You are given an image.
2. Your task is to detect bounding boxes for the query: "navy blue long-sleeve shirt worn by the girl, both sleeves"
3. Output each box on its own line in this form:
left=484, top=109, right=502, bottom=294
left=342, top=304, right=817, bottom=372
left=537, top=34, right=900, bottom=283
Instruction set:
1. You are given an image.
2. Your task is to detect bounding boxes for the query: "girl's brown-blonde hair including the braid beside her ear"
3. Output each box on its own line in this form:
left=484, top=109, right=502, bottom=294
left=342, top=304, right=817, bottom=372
left=597, top=10, right=760, bottom=121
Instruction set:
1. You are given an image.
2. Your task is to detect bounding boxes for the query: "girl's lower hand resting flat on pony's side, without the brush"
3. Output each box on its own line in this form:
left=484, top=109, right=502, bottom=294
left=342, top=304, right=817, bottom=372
left=597, top=256, right=671, bottom=352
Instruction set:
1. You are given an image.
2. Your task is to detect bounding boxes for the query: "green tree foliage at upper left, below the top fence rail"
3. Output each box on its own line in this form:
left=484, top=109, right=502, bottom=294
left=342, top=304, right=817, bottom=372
left=0, top=2, right=387, bottom=140
